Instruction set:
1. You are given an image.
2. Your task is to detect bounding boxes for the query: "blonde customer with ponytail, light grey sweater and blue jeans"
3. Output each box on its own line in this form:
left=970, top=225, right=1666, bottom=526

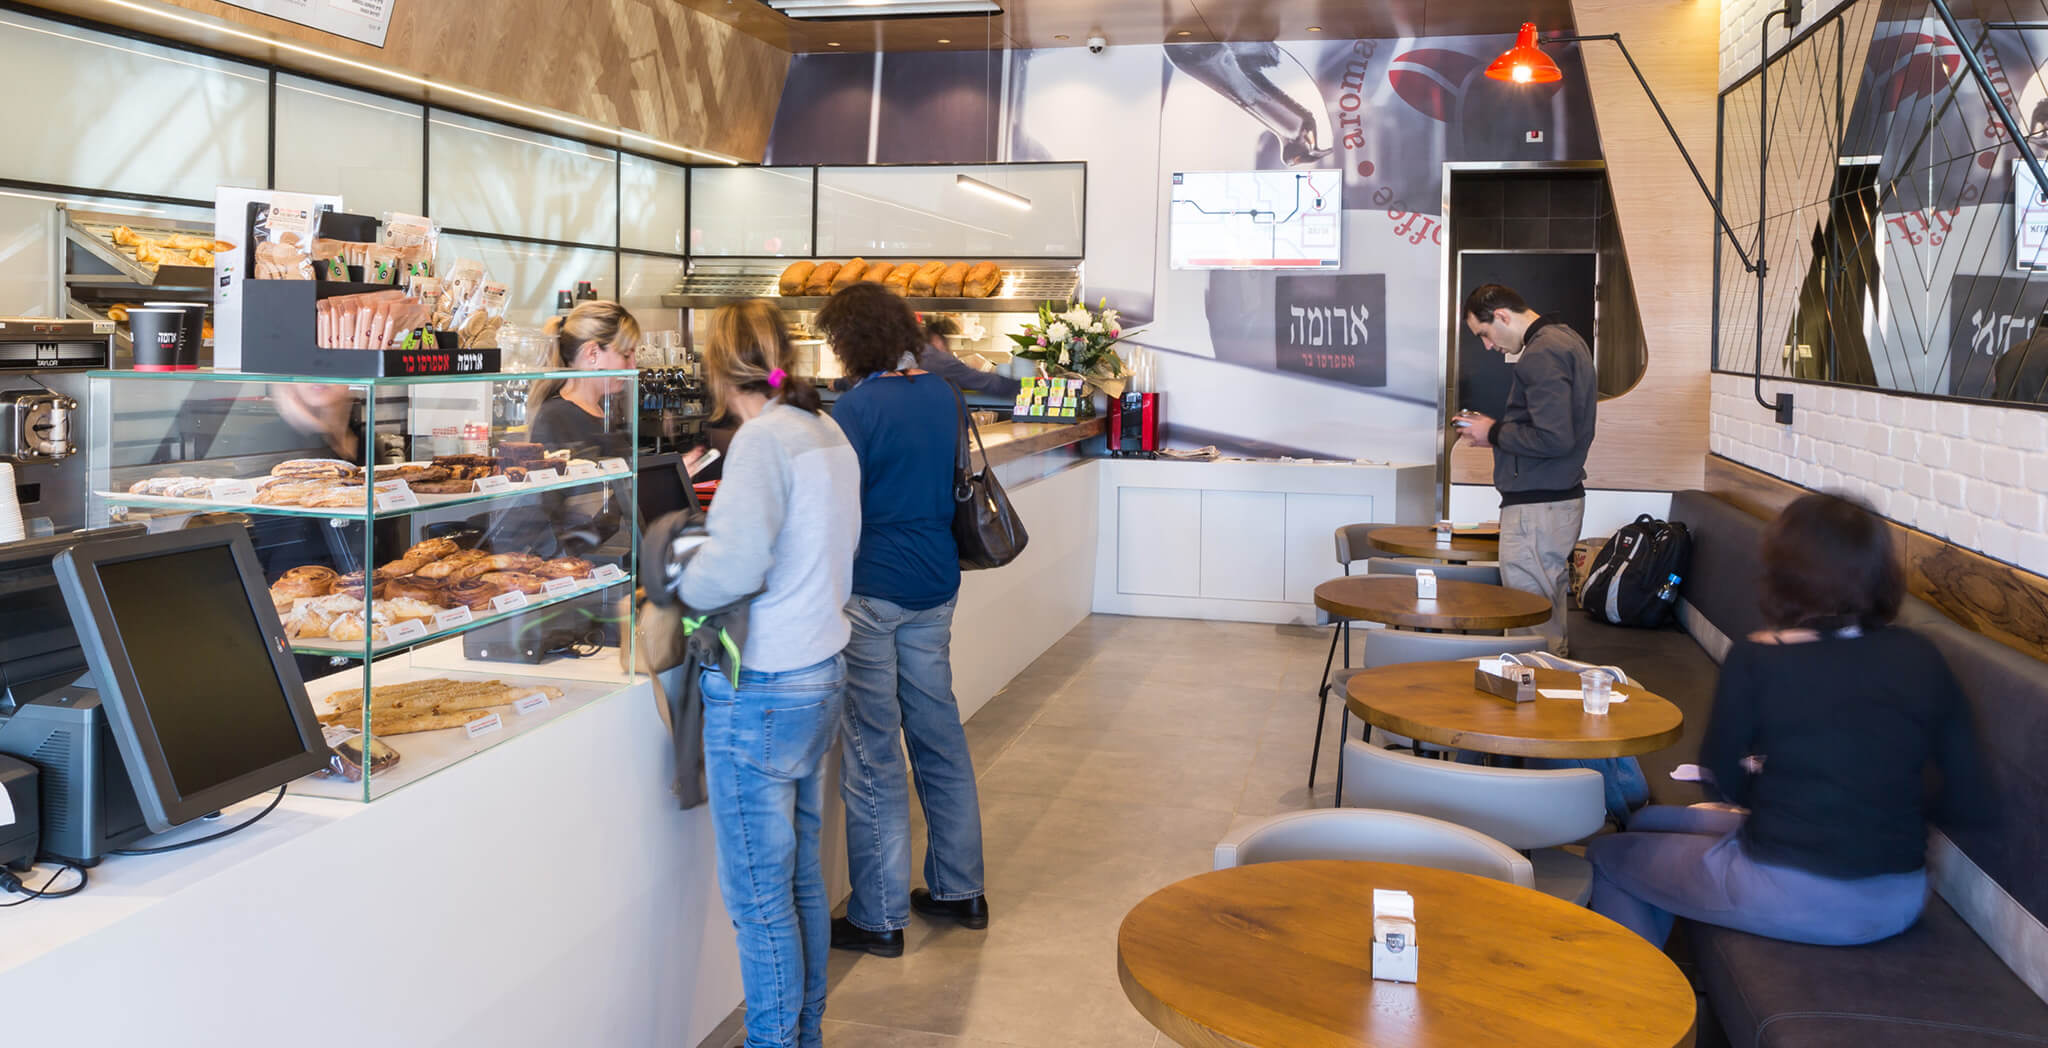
left=680, top=301, right=860, bottom=1048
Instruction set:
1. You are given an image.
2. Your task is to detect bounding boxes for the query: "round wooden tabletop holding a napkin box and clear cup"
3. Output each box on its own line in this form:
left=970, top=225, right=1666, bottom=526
left=1343, top=661, right=1686, bottom=757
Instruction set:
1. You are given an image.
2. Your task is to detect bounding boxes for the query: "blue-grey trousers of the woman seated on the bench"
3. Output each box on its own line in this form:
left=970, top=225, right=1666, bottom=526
left=1585, top=806, right=1927, bottom=946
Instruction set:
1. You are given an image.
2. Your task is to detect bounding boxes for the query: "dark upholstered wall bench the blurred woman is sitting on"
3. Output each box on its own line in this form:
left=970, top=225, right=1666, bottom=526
left=1605, top=491, right=2048, bottom=1048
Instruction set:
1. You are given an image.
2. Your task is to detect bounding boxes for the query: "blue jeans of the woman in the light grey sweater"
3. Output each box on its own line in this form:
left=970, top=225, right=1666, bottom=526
left=700, top=655, right=846, bottom=1048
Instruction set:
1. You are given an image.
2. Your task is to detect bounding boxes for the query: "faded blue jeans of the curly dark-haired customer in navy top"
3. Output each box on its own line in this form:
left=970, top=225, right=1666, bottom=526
left=840, top=594, right=981, bottom=931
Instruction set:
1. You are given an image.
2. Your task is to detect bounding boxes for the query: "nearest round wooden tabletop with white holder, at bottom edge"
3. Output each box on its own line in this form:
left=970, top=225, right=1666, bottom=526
left=1116, top=862, right=1694, bottom=1048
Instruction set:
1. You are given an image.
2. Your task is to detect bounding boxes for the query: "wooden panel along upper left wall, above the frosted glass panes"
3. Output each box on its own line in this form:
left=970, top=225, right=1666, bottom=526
left=25, top=0, right=788, bottom=160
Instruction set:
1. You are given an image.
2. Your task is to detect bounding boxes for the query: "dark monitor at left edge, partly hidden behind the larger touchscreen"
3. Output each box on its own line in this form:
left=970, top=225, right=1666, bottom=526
left=0, top=524, right=147, bottom=712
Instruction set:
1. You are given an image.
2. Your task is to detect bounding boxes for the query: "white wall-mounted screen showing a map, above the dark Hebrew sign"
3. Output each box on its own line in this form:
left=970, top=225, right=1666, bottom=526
left=1167, top=170, right=1343, bottom=270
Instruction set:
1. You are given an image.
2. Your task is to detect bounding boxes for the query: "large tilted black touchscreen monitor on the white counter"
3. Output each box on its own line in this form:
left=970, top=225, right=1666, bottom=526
left=55, top=524, right=328, bottom=833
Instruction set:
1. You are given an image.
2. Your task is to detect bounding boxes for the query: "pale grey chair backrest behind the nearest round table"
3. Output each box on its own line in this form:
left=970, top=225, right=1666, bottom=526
left=1217, top=809, right=1536, bottom=888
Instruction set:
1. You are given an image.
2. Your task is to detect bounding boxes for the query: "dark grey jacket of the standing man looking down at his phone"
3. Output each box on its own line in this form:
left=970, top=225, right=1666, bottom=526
left=1489, top=317, right=1599, bottom=506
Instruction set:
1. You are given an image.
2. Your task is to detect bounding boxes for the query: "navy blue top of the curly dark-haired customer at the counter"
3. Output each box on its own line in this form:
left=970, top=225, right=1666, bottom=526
left=831, top=375, right=961, bottom=612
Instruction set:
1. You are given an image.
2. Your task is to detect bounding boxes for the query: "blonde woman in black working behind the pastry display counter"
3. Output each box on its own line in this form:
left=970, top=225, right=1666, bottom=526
left=526, top=301, right=641, bottom=459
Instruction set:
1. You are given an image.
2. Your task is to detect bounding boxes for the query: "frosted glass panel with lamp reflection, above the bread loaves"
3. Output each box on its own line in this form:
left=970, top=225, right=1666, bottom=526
left=817, top=164, right=1087, bottom=258
